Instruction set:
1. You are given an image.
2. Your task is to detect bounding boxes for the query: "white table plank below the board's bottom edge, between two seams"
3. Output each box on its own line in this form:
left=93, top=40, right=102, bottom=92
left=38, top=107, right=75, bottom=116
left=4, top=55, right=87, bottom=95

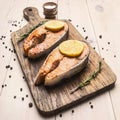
left=56, top=92, right=114, bottom=120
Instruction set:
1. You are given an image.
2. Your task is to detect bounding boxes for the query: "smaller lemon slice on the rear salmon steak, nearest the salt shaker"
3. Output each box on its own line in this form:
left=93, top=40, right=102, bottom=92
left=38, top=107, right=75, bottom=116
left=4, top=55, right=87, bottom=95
left=45, top=20, right=64, bottom=32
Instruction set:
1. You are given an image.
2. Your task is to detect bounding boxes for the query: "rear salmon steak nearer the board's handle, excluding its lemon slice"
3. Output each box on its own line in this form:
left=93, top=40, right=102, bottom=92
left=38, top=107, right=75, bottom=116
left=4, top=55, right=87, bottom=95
left=23, top=22, right=68, bottom=59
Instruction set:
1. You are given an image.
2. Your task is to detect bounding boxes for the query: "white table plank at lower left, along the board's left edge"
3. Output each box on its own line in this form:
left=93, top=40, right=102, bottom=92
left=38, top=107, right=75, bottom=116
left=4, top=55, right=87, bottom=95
left=0, top=54, right=55, bottom=120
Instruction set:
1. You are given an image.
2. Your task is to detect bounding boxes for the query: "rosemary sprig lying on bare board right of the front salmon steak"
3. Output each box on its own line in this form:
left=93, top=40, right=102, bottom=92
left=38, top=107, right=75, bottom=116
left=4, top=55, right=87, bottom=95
left=70, top=61, right=102, bottom=94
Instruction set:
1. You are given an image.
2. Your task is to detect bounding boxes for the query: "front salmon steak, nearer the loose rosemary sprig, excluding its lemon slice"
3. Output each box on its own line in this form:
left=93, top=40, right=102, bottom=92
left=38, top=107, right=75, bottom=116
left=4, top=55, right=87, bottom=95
left=35, top=41, right=90, bottom=86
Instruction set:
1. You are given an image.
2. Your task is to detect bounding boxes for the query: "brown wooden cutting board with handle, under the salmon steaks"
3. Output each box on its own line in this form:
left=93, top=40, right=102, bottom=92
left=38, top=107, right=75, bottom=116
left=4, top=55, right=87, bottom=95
left=11, top=7, right=116, bottom=115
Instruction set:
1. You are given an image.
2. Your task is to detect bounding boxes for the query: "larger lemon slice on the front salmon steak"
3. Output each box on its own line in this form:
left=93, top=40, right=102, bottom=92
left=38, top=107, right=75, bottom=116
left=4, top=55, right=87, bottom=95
left=59, top=40, right=84, bottom=57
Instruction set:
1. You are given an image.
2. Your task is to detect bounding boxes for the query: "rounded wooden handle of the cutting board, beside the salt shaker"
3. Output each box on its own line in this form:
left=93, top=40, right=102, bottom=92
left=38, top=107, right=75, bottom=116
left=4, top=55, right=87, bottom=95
left=23, top=7, right=44, bottom=23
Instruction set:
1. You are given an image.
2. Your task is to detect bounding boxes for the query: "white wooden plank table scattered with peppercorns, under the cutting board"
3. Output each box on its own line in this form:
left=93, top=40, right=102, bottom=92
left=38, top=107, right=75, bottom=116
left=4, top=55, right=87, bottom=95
left=0, top=0, right=120, bottom=120
